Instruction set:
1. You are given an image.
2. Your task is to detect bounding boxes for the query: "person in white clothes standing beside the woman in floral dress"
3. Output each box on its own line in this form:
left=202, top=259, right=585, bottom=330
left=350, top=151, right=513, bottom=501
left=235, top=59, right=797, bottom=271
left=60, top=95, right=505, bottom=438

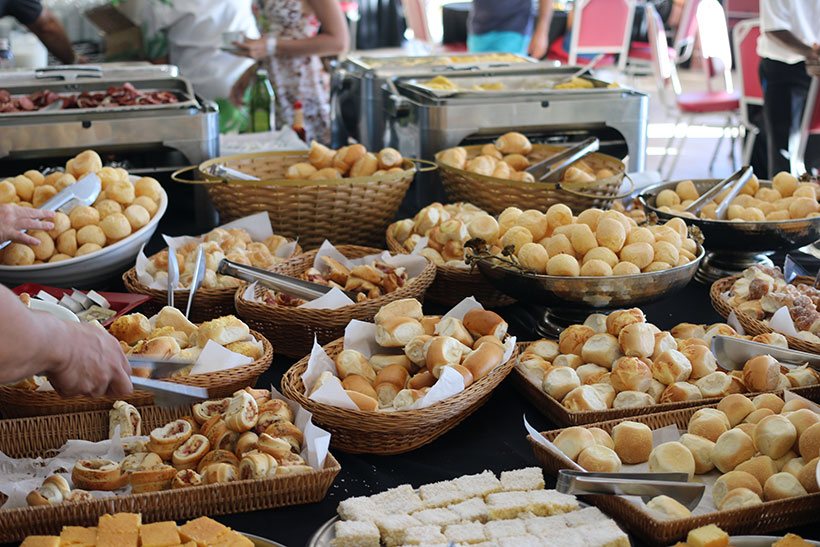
left=141, top=0, right=259, bottom=132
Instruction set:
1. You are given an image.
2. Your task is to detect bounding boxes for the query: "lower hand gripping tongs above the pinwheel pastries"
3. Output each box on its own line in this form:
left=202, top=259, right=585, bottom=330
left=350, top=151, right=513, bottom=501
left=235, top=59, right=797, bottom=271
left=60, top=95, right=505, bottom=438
left=46, top=323, right=133, bottom=397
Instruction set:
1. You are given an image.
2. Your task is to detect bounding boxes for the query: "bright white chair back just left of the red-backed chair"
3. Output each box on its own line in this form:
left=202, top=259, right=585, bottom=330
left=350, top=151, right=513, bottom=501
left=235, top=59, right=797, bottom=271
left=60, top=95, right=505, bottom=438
left=697, top=0, right=734, bottom=93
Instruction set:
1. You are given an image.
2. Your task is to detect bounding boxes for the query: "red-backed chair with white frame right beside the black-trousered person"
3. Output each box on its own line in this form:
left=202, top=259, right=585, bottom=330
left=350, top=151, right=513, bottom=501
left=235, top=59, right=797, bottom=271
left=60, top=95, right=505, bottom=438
left=732, top=19, right=763, bottom=165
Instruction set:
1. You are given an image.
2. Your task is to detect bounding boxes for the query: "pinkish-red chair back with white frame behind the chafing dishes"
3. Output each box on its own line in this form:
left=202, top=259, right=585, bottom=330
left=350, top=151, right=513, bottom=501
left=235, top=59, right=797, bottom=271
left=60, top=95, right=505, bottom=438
left=569, top=0, right=635, bottom=69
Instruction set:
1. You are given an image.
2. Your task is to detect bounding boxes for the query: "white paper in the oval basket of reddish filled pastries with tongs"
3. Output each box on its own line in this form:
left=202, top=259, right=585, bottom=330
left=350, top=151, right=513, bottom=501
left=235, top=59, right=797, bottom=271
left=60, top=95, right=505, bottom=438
left=242, top=240, right=427, bottom=310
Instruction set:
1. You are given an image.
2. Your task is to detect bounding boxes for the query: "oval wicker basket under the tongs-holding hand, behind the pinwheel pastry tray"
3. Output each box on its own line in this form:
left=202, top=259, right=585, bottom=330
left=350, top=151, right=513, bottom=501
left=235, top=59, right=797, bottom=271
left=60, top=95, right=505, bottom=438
left=0, top=331, right=273, bottom=418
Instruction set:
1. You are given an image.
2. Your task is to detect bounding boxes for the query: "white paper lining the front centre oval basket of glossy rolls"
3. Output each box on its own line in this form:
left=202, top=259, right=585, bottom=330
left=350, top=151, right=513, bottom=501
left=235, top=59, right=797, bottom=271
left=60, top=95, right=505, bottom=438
left=302, top=296, right=515, bottom=412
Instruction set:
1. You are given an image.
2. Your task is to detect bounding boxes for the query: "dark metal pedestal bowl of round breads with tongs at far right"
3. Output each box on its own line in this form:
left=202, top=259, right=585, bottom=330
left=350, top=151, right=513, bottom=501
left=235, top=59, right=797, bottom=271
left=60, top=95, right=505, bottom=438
left=638, top=179, right=820, bottom=282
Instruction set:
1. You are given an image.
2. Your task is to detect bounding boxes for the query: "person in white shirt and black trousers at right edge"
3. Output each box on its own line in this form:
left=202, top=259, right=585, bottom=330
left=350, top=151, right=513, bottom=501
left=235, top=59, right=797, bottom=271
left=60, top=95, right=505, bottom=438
left=757, top=0, right=820, bottom=177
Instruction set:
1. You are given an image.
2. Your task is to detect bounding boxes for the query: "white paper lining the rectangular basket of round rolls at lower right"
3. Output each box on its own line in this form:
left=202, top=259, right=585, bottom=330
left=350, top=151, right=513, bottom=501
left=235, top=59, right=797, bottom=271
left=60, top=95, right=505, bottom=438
left=524, top=390, right=820, bottom=519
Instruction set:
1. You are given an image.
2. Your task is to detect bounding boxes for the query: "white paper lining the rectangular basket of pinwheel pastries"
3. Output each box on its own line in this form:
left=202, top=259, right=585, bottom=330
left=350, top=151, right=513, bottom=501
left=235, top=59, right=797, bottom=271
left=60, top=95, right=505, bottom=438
left=0, top=385, right=330, bottom=510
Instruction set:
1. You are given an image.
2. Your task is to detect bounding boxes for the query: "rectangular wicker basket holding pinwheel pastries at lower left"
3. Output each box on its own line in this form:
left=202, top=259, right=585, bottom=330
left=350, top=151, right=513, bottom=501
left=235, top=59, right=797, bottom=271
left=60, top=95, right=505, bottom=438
left=0, top=407, right=341, bottom=543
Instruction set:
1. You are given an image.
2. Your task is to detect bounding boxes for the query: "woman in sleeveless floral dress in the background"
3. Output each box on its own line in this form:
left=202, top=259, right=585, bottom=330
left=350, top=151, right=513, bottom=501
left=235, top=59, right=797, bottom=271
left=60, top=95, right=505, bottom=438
left=231, top=0, right=349, bottom=143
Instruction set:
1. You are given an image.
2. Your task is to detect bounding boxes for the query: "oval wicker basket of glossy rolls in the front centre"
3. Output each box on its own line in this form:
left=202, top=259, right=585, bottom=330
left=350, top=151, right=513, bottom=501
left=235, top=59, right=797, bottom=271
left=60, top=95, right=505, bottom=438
left=282, top=340, right=517, bottom=455
